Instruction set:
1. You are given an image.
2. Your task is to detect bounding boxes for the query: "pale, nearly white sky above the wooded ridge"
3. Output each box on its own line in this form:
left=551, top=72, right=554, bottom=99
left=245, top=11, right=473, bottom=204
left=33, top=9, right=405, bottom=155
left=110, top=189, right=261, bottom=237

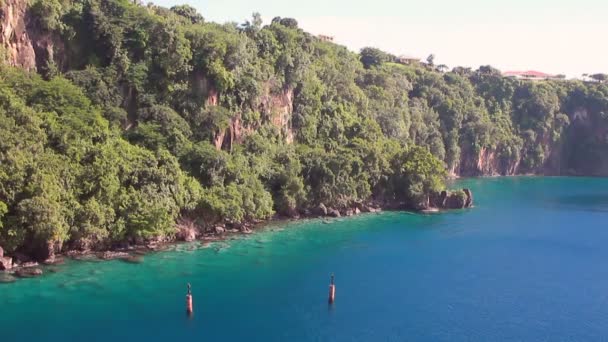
left=154, top=0, right=608, bottom=77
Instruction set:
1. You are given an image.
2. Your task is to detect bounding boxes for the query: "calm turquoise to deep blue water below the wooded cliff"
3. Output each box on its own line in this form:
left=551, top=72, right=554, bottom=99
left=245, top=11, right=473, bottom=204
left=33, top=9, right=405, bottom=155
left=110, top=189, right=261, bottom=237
left=0, top=178, right=608, bottom=341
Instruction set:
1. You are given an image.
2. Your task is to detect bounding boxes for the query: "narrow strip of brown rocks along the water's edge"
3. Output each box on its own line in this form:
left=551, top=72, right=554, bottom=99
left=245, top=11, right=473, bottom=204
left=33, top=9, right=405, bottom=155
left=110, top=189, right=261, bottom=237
left=0, top=189, right=473, bottom=283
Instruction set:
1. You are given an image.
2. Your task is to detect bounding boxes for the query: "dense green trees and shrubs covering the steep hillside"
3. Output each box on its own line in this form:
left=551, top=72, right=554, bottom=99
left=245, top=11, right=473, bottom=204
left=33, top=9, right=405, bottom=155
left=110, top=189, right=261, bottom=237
left=0, top=0, right=608, bottom=257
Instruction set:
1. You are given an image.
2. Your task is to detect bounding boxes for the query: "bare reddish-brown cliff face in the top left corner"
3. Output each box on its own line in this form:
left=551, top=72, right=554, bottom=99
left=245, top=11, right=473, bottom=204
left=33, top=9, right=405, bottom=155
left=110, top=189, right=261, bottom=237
left=0, top=0, right=61, bottom=72
